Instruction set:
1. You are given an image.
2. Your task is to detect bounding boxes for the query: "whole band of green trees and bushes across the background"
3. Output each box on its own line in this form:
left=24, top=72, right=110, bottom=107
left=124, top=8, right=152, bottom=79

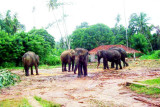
left=0, top=11, right=160, bottom=67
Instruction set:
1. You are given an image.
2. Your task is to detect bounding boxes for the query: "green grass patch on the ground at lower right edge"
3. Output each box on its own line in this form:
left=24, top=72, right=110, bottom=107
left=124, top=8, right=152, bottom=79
left=130, top=84, right=160, bottom=95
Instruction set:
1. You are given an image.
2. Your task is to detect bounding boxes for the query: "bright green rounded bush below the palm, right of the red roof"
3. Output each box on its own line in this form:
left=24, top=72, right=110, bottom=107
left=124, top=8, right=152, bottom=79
left=130, top=33, right=150, bottom=53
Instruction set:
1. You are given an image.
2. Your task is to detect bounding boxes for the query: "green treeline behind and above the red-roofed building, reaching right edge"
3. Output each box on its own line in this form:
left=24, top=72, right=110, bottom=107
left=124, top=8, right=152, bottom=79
left=70, top=13, right=160, bottom=53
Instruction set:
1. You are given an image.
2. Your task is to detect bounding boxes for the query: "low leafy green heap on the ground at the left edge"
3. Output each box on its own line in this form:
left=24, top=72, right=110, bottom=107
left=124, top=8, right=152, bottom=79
left=0, top=69, right=20, bottom=88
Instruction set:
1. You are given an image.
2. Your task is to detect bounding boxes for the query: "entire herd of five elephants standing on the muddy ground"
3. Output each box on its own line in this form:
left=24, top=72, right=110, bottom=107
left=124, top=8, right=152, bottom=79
left=22, top=47, right=128, bottom=77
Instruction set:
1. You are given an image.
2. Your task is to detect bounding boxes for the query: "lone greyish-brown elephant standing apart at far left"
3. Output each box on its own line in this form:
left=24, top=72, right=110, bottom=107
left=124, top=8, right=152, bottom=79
left=22, top=51, right=39, bottom=76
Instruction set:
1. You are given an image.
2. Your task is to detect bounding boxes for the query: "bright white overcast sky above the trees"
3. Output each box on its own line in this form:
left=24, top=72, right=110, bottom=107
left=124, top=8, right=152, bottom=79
left=0, top=0, right=160, bottom=41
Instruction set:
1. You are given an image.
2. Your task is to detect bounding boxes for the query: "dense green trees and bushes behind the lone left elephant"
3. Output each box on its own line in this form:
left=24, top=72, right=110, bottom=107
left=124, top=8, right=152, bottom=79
left=0, top=11, right=61, bottom=67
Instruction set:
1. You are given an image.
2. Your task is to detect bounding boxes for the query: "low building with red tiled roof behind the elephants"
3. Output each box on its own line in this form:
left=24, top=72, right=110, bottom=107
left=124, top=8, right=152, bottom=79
left=89, top=45, right=141, bottom=62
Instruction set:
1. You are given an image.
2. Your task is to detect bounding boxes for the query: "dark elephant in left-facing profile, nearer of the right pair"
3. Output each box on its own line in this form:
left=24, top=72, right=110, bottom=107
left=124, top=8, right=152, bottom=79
left=97, top=50, right=122, bottom=70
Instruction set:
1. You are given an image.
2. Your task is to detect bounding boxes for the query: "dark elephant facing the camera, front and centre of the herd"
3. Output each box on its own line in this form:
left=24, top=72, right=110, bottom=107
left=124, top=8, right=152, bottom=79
left=74, top=48, right=88, bottom=77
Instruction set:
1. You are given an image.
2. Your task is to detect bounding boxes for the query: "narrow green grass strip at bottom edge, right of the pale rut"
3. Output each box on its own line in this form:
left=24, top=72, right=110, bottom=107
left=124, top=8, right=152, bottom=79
left=34, top=96, right=61, bottom=107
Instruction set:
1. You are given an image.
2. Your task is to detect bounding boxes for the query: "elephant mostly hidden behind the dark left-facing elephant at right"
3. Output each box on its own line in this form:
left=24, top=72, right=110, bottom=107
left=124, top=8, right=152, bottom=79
left=109, top=47, right=129, bottom=68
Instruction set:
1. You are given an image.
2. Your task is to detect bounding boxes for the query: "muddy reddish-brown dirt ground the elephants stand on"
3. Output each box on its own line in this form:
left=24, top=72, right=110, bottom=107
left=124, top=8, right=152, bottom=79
left=0, top=60, right=160, bottom=107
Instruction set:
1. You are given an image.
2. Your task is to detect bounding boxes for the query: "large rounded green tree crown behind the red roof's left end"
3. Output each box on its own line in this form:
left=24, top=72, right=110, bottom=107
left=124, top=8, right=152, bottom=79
left=71, top=24, right=114, bottom=50
